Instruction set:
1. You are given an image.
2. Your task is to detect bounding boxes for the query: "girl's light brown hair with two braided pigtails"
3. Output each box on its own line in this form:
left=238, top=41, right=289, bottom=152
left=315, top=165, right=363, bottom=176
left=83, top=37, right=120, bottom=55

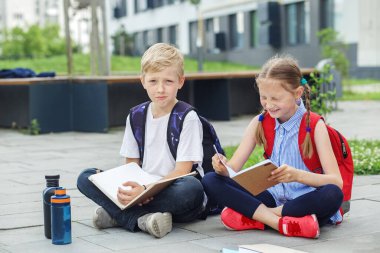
left=255, top=55, right=313, bottom=158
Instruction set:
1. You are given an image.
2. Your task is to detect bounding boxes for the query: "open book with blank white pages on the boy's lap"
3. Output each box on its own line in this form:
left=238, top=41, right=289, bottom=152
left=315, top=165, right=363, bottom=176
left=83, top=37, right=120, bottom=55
left=89, top=163, right=196, bottom=209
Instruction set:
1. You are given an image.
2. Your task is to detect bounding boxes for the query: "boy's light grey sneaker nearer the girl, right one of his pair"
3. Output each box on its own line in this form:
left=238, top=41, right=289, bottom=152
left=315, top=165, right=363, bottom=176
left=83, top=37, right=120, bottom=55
left=137, top=212, right=172, bottom=238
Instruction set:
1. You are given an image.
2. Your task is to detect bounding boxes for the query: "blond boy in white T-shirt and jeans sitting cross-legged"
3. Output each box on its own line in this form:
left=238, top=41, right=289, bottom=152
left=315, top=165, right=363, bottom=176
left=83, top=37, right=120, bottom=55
left=78, top=43, right=204, bottom=238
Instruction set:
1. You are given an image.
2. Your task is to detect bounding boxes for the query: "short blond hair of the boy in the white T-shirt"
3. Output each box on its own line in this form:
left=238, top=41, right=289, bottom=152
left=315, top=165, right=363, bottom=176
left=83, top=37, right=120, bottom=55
left=141, top=43, right=184, bottom=77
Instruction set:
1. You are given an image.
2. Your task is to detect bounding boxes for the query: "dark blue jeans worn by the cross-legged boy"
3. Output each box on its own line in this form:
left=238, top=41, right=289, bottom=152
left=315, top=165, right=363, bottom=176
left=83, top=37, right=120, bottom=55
left=77, top=168, right=204, bottom=232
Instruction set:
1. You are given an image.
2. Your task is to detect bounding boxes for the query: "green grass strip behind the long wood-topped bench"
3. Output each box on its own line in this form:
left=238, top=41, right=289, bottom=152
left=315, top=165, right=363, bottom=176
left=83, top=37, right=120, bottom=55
left=0, top=54, right=258, bottom=75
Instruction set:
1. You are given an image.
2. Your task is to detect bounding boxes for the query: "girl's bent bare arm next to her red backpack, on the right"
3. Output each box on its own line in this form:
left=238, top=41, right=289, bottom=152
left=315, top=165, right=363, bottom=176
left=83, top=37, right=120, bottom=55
left=288, top=120, right=343, bottom=188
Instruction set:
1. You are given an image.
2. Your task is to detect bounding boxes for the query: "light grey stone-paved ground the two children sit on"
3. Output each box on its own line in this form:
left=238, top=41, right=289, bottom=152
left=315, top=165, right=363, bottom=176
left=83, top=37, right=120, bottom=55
left=0, top=102, right=380, bottom=253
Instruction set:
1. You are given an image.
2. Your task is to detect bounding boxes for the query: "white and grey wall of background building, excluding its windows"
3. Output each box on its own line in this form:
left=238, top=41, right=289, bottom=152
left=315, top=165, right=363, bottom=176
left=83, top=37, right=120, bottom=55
left=110, top=0, right=380, bottom=76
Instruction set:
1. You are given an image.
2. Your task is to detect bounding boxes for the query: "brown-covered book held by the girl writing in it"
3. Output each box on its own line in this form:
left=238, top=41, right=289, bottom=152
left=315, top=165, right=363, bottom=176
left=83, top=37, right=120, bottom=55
left=227, top=159, right=278, bottom=196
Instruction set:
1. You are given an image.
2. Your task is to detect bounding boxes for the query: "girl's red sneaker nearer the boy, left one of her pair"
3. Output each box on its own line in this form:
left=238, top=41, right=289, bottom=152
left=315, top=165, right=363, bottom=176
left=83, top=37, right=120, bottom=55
left=220, top=207, right=264, bottom=230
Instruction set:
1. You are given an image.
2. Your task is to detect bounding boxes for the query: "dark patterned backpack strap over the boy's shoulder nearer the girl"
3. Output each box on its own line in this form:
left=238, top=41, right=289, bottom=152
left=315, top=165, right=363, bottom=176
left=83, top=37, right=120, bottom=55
left=166, top=101, right=196, bottom=160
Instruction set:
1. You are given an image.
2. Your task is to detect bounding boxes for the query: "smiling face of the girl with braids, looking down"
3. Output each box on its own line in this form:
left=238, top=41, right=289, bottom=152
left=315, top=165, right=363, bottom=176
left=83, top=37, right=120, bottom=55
left=258, top=78, right=303, bottom=123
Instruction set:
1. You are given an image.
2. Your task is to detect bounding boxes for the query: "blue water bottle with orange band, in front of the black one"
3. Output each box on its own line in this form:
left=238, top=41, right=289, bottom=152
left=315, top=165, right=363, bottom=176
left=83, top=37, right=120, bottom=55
left=51, top=187, right=71, bottom=245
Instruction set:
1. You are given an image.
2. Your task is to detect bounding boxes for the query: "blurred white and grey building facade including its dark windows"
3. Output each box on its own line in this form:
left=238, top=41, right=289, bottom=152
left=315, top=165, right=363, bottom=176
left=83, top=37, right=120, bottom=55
left=109, top=0, right=380, bottom=78
